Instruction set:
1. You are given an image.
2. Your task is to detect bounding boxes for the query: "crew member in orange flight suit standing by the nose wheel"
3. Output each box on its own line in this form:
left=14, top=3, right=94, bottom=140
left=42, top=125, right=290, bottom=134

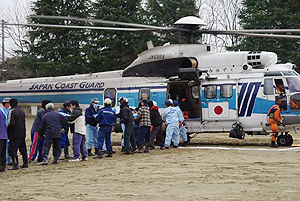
left=268, top=96, right=283, bottom=148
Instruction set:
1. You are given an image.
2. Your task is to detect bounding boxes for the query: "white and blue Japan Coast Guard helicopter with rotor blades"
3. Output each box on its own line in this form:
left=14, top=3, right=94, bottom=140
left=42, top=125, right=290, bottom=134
left=0, top=16, right=300, bottom=146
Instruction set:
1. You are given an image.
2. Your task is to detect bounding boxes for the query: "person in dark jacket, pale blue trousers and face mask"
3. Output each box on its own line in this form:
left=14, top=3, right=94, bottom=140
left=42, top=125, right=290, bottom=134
left=85, top=98, right=102, bottom=156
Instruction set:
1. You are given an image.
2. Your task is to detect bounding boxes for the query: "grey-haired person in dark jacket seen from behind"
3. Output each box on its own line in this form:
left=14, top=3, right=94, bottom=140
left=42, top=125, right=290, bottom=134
left=39, top=103, right=67, bottom=165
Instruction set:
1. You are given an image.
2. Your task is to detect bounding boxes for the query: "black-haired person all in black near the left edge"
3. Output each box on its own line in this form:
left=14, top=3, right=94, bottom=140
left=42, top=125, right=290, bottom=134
left=7, top=98, right=28, bottom=170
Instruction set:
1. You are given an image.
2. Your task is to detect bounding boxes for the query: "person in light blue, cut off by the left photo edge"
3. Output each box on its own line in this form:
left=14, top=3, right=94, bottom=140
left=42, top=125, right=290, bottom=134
left=0, top=98, right=10, bottom=172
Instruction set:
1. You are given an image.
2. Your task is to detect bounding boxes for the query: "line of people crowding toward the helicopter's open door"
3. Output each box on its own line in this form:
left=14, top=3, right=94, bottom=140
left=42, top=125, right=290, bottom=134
left=0, top=97, right=188, bottom=172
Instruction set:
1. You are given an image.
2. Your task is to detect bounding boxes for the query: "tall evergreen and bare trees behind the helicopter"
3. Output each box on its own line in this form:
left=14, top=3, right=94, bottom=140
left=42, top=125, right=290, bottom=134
left=1, top=0, right=300, bottom=79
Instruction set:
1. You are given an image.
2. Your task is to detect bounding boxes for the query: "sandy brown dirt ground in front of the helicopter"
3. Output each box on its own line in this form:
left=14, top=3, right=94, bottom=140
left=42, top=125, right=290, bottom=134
left=0, top=117, right=300, bottom=201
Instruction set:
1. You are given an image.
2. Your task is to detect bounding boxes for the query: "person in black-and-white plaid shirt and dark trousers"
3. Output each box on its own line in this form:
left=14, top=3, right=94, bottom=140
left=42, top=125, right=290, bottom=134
left=137, top=100, right=151, bottom=153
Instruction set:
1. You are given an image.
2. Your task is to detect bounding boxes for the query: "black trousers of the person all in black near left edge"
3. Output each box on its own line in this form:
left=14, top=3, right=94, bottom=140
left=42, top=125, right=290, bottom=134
left=8, top=137, right=28, bottom=165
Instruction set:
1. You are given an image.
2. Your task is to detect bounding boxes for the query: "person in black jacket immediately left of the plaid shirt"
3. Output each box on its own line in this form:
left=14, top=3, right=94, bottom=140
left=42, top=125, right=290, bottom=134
left=117, top=97, right=137, bottom=154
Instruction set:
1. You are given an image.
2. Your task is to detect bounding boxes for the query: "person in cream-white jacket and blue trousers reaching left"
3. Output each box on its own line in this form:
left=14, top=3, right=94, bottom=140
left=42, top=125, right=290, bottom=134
left=68, top=100, right=88, bottom=162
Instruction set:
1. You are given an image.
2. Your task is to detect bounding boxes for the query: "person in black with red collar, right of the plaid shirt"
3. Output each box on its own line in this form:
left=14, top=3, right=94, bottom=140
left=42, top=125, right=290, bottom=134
left=148, top=101, right=164, bottom=149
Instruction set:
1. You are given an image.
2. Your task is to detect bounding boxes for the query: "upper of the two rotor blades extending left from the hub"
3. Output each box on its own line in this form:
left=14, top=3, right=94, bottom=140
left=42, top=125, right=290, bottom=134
left=30, top=15, right=176, bottom=30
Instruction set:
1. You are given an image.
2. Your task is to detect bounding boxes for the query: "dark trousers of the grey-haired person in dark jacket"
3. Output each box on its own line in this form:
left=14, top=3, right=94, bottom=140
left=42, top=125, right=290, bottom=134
left=42, top=136, right=60, bottom=161
